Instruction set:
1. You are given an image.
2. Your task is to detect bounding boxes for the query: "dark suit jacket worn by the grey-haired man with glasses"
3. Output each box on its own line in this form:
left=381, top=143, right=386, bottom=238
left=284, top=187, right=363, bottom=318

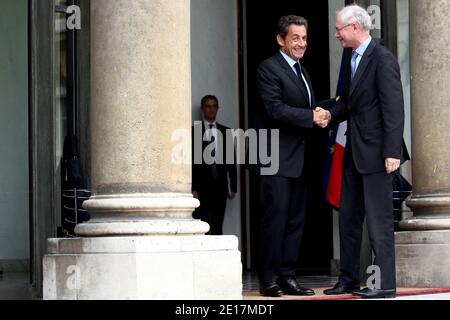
left=330, top=40, right=406, bottom=174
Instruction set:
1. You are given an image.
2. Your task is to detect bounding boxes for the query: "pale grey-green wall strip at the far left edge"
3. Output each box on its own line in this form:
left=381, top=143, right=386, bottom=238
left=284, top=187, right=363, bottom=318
left=0, top=0, right=29, bottom=262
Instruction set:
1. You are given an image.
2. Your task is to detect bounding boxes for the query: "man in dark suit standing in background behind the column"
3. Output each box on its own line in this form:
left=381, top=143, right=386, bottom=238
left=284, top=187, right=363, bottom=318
left=192, top=95, right=237, bottom=235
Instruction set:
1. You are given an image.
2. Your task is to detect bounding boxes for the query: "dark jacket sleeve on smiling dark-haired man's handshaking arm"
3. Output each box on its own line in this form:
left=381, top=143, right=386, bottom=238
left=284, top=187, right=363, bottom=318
left=256, top=65, right=313, bottom=128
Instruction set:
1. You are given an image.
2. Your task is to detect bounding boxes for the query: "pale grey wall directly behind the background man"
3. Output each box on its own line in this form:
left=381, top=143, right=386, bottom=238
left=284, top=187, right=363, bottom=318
left=191, top=0, right=241, bottom=242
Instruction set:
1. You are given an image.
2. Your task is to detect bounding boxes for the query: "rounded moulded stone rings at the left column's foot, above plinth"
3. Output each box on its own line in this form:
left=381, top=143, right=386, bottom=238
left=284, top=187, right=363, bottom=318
left=75, top=193, right=209, bottom=237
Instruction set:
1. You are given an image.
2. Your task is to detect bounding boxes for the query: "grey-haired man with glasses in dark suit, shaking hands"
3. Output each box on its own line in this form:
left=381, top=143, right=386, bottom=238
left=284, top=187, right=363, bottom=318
left=318, top=6, right=404, bottom=298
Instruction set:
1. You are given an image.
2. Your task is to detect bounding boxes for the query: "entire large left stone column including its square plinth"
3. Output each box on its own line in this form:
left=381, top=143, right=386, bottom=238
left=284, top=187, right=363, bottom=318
left=44, top=0, right=242, bottom=300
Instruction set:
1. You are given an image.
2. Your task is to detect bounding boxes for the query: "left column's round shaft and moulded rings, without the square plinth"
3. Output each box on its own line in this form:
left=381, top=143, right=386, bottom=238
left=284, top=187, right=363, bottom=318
left=76, top=0, right=208, bottom=236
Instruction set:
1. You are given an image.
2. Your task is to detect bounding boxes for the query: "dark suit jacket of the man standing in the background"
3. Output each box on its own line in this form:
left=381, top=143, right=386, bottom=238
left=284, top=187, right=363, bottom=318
left=192, top=121, right=237, bottom=195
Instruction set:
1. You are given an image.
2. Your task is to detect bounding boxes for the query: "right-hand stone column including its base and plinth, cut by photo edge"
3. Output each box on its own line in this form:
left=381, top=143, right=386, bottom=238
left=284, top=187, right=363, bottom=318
left=396, top=0, right=450, bottom=287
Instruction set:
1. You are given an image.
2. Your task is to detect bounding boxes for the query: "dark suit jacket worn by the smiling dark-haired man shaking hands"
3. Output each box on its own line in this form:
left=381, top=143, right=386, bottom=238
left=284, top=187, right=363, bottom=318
left=250, top=52, right=334, bottom=178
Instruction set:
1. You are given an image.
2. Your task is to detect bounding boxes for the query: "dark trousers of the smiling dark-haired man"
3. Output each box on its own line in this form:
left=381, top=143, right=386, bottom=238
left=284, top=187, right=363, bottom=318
left=258, top=176, right=306, bottom=283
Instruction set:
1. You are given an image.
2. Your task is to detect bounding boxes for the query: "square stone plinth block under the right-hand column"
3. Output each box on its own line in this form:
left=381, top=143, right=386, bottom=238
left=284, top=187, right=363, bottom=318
left=395, top=230, right=450, bottom=288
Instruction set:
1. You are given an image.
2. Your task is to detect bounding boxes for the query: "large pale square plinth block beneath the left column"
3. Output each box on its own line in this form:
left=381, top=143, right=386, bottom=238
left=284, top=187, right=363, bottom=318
left=43, top=235, right=242, bottom=300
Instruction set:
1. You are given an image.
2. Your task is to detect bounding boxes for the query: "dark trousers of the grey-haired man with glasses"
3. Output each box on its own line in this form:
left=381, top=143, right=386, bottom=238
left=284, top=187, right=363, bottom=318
left=339, top=149, right=396, bottom=289
